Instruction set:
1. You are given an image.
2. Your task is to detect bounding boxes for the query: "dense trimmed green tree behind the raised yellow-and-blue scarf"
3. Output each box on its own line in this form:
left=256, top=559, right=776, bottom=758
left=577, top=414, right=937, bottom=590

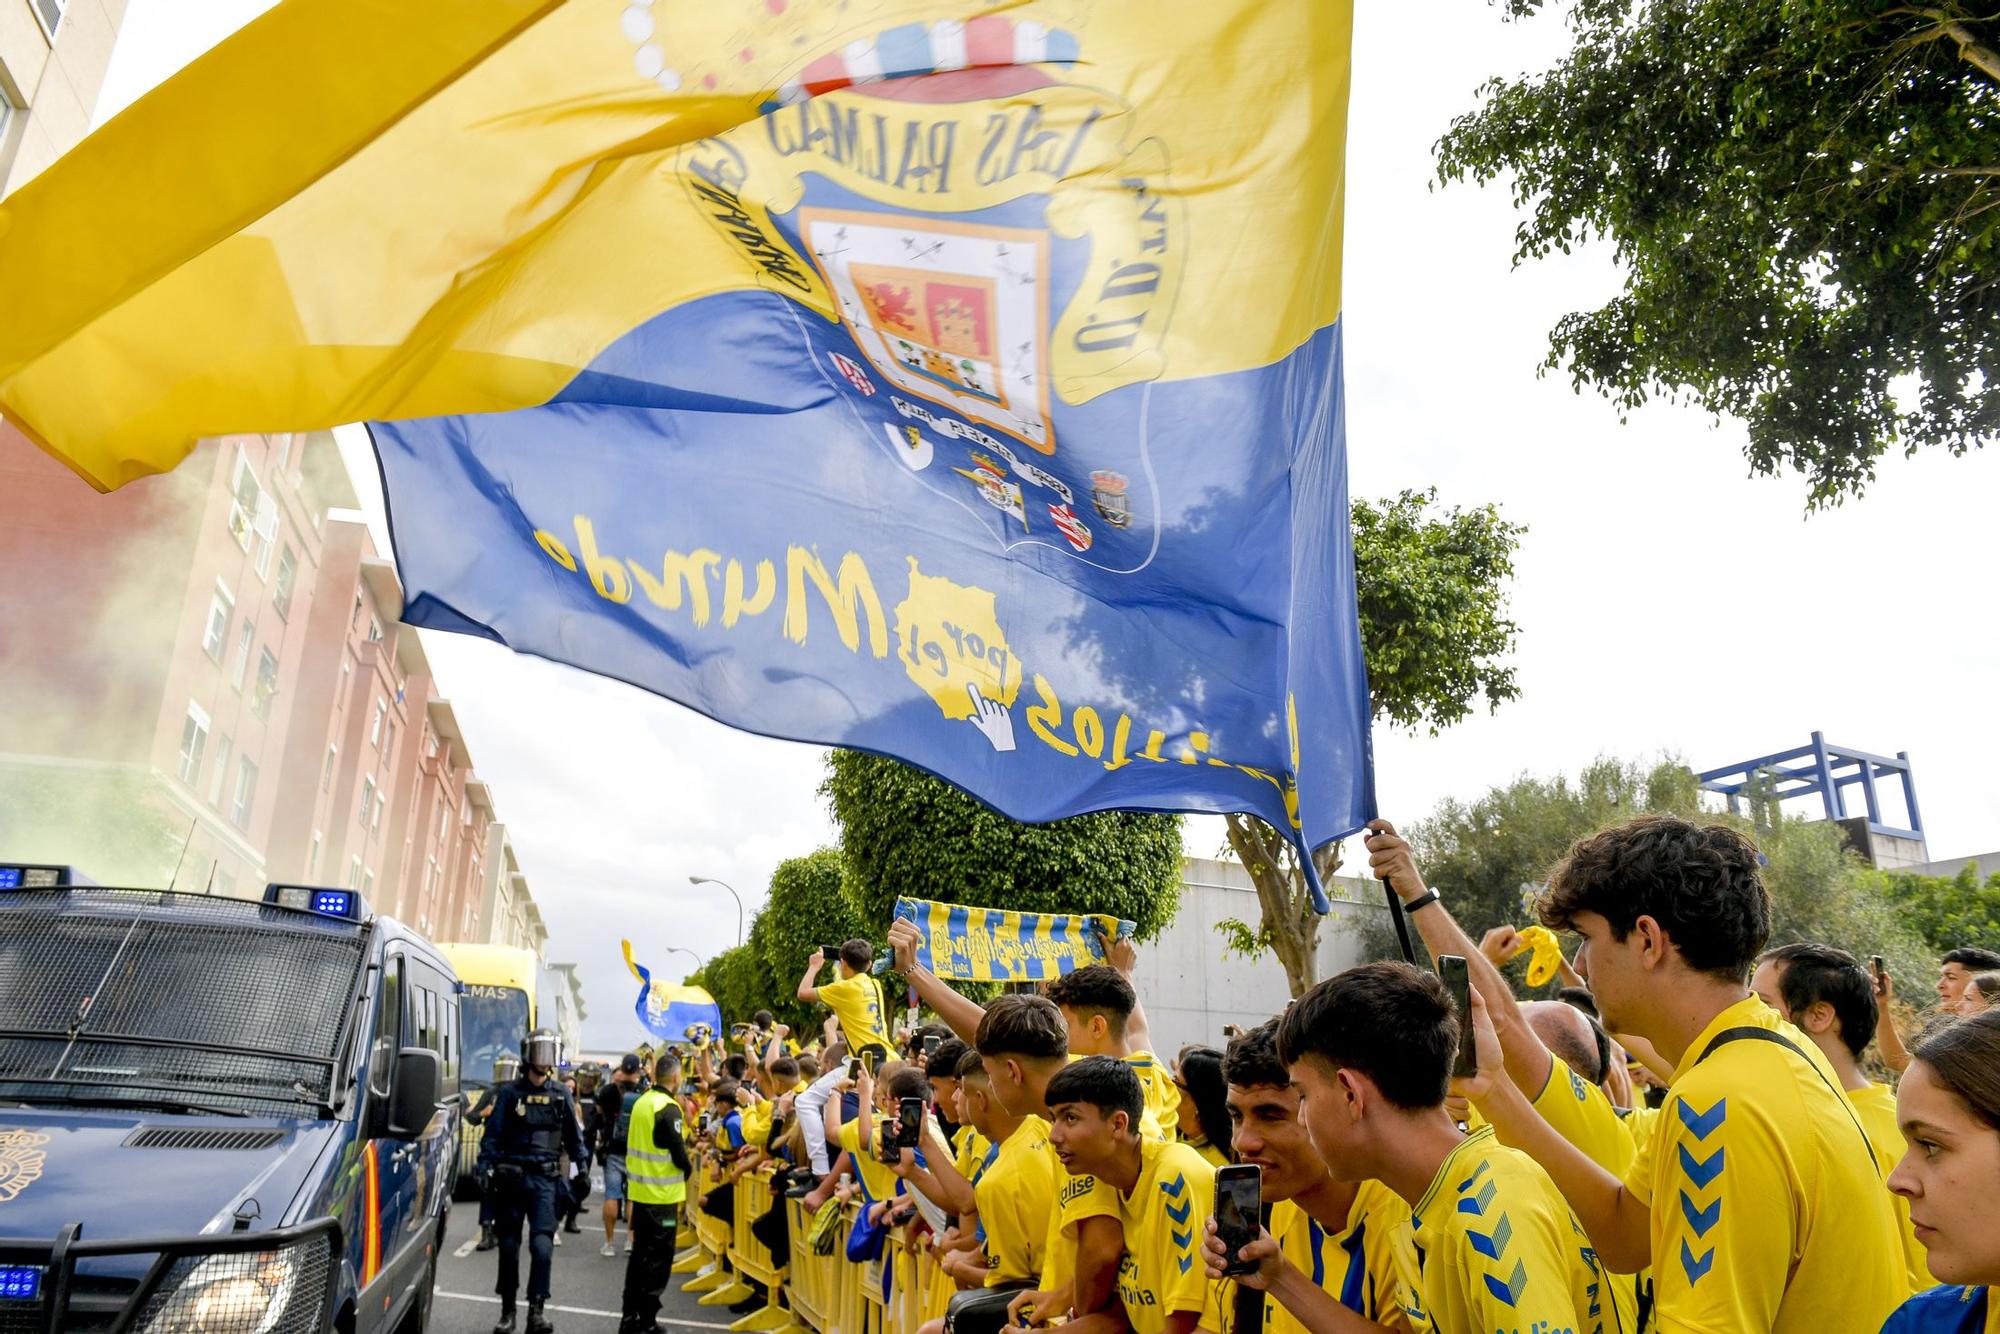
left=820, top=750, right=1182, bottom=942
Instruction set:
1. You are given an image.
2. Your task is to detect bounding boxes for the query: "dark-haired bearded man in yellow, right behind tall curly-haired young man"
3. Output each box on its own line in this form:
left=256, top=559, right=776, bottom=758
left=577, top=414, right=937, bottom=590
left=1750, top=944, right=1932, bottom=1294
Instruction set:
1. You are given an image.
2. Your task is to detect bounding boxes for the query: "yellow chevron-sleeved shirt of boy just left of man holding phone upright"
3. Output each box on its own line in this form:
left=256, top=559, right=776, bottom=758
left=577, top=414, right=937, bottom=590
left=1112, top=1140, right=1228, bottom=1334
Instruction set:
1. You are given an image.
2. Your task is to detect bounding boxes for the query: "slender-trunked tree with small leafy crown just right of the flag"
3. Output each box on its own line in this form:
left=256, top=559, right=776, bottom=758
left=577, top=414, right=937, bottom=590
left=1216, top=490, right=1526, bottom=996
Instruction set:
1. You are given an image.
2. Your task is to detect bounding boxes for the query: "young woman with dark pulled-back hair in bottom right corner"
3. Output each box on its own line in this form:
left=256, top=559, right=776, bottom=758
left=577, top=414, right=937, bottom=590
left=1882, top=1010, right=2000, bottom=1334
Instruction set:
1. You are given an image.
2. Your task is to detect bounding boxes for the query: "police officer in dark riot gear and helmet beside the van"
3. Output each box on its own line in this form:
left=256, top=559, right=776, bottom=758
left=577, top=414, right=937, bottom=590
left=480, top=1028, right=590, bottom=1334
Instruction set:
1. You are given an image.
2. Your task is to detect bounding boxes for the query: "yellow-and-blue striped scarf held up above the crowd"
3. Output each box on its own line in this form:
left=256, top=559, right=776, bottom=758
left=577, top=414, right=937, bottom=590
left=900, top=898, right=1134, bottom=982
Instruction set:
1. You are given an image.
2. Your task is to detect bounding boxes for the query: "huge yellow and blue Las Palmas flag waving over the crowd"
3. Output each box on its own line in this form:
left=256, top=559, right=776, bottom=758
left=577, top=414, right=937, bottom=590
left=0, top=0, right=1374, bottom=908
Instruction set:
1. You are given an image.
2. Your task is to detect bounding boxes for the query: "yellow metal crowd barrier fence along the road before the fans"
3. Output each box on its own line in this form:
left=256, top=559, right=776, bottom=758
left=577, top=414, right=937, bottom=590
left=674, top=1164, right=956, bottom=1334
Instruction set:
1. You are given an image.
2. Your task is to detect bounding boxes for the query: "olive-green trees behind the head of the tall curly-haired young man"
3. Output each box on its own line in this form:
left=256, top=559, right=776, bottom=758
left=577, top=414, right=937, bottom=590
left=1370, top=760, right=1928, bottom=980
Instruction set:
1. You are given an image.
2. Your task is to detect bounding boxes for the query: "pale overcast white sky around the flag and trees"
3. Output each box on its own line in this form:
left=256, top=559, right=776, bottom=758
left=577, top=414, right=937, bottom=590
left=100, top=0, right=2000, bottom=1048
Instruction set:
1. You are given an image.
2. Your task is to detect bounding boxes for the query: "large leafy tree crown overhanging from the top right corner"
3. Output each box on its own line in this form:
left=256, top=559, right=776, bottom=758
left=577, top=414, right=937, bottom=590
left=1438, top=0, right=2000, bottom=504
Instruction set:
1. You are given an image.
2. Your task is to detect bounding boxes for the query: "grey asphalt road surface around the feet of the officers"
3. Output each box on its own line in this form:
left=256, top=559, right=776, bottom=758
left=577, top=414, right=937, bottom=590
left=430, top=1194, right=734, bottom=1334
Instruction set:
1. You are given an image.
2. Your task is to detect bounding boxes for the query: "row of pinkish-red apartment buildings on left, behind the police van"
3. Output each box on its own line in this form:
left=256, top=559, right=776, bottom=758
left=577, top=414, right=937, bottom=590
left=0, top=428, right=546, bottom=952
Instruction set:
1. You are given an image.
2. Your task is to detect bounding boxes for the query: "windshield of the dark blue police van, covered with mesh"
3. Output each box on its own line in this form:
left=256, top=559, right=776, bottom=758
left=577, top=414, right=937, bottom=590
left=0, top=888, right=366, bottom=1116
